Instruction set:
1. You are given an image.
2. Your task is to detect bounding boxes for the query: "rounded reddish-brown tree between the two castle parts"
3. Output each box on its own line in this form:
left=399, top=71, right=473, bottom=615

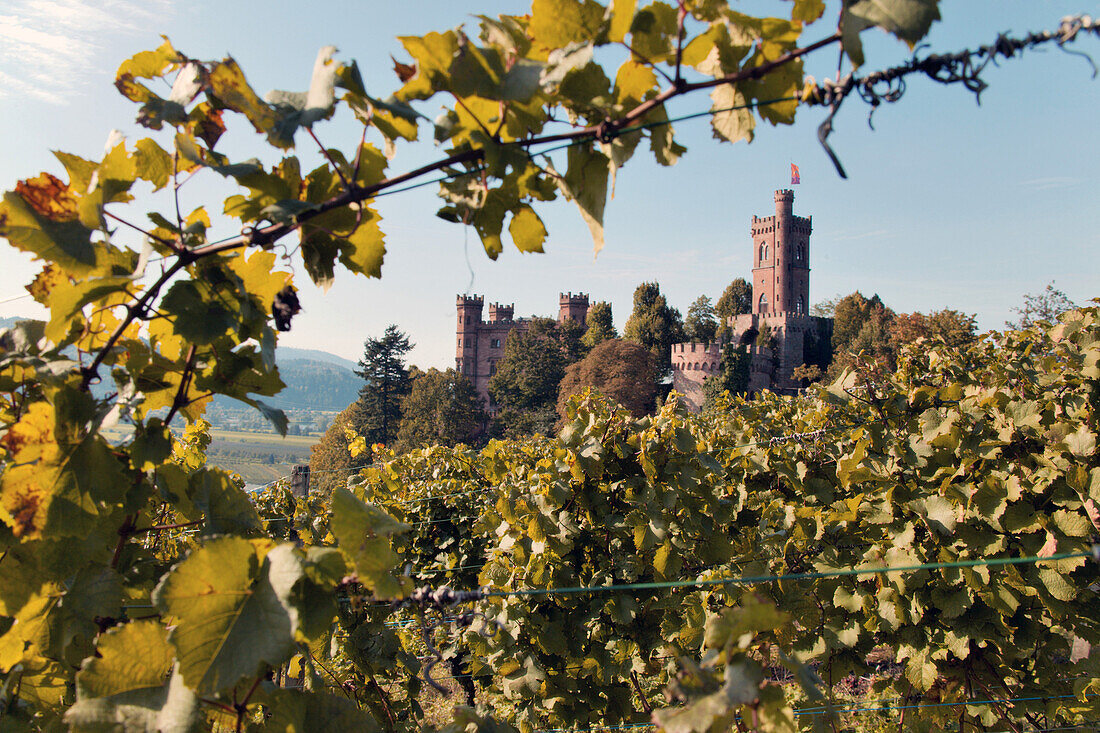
left=558, top=339, right=657, bottom=419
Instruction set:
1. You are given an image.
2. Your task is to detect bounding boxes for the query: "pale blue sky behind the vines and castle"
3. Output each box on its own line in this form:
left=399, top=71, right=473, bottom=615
left=0, top=0, right=1100, bottom=368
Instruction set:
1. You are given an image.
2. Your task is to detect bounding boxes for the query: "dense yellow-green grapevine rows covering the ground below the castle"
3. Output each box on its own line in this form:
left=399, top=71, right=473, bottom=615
left=0, top=309, right=1100, bottom=732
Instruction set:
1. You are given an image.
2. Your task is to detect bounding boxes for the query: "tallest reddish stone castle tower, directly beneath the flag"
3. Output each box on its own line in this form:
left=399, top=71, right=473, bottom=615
left=751, top=189, right=813, bottom=315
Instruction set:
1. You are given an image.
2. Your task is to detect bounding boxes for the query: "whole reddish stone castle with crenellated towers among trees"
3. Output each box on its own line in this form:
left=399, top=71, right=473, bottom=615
left=454, top=189, right=833, bottom=414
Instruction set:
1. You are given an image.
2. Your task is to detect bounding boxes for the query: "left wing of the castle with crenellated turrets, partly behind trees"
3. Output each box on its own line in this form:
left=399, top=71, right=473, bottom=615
left=454, top=293, right=589, bottom=415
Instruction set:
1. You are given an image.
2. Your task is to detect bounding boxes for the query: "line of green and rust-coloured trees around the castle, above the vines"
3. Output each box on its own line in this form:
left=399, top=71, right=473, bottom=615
left=310, top=277, right=1074, bottom=489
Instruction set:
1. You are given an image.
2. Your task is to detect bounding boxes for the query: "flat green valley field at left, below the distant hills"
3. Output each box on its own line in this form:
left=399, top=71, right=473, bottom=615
left=103, top=427, right=320, bottom=484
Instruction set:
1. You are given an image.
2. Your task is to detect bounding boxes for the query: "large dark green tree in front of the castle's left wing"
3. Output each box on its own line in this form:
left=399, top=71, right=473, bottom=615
left=488, top=318, right=568, bottom=436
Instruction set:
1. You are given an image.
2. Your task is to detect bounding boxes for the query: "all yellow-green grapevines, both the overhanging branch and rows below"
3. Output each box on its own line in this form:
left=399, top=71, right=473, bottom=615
left=0, top=0, right=1100, bottom=733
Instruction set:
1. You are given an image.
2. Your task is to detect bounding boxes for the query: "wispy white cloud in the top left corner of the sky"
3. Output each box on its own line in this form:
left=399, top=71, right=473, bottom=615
left=0, top=0, right=171, bottom=105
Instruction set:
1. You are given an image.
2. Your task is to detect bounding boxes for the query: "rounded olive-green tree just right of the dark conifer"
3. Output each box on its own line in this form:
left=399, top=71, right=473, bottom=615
left=395, top=369, right=486, bottom=451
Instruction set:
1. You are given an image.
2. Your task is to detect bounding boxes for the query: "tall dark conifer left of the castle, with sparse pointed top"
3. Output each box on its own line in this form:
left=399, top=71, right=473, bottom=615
left=354, top=325, right=413, bottom=444
